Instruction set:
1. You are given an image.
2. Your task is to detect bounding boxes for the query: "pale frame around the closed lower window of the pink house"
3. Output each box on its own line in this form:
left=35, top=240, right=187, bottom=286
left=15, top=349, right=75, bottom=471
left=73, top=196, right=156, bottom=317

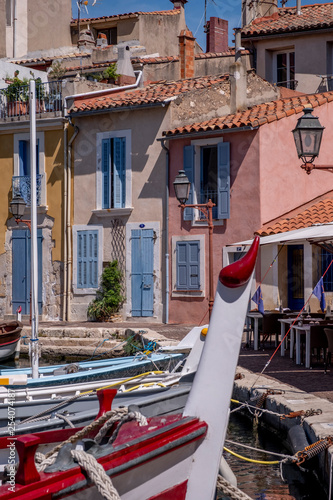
left=171, top=234, right=206, bottom=297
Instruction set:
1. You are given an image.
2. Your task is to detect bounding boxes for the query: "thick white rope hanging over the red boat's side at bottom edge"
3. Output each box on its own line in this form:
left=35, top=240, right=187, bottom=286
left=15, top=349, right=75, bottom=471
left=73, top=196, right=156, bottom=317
left=71, top=450, right=121, bottom=500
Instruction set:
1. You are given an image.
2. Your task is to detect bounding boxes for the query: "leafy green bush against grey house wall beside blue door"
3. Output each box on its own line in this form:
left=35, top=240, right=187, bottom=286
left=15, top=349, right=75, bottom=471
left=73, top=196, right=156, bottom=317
left=87, top=260, right=125, bottom=321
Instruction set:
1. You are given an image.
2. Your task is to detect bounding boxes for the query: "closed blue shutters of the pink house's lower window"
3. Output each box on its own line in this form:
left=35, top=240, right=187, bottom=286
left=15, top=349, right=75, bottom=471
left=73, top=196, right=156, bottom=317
left=176, top=241, right=200, bottom=290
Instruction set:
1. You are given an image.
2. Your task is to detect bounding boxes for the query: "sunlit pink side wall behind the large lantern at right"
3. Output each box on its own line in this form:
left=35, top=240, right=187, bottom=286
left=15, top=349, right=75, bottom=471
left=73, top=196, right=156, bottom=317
left=259, top=104, right=333, bottom=224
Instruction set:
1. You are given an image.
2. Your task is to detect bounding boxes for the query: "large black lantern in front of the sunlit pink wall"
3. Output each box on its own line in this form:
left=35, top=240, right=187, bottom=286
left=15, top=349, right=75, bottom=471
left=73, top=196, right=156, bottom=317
left=292, top=108, right=326, bottom=174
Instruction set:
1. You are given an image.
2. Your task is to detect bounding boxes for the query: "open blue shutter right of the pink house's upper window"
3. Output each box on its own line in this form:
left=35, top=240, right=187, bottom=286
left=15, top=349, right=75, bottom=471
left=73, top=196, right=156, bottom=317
left=217, top=142, right=230, bottom=219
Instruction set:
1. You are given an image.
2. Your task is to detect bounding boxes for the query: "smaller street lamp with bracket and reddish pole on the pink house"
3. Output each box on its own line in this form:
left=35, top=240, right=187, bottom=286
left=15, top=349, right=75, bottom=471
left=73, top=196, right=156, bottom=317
left=173, top=170, right=216, bottom=318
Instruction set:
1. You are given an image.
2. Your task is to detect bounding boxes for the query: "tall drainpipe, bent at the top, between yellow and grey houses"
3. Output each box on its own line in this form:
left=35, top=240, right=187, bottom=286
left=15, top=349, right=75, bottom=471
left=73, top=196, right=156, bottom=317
left=64, top=118, right=79, bottom=321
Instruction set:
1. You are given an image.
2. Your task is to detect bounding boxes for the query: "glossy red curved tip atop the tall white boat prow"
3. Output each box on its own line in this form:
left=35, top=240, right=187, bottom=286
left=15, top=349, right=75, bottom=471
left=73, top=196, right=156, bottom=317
left=219, top=236, right=259, bottom=288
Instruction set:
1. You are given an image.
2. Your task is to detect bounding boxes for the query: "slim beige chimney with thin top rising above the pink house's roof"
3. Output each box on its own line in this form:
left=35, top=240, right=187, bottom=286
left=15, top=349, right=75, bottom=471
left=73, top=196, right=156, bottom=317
left=229, top=28, right=247, bottom=114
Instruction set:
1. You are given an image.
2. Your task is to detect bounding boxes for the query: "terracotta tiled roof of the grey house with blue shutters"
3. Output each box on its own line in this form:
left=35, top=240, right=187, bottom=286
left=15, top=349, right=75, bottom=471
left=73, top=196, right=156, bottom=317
left=71, top=75, right=229, bottom=114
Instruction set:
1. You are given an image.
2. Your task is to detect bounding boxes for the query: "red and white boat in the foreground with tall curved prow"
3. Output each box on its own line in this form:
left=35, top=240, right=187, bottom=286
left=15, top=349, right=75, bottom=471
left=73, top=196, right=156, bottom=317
left=0, top=238, right=259, bottom=500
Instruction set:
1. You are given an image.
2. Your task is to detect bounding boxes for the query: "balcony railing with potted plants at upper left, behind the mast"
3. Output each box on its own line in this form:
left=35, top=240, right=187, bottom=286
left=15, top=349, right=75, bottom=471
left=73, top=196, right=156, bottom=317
left=0, top=81, right=63, bottom=120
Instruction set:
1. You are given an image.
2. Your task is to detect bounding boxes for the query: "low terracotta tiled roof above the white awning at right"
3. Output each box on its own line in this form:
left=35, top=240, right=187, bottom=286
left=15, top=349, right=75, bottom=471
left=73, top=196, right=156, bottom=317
left=256, top=199, right=333, bottom=236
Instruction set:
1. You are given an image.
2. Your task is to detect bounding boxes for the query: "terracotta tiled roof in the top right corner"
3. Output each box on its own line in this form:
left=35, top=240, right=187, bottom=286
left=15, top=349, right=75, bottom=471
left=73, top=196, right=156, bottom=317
left=242, top=2, right=333, bottom=38
